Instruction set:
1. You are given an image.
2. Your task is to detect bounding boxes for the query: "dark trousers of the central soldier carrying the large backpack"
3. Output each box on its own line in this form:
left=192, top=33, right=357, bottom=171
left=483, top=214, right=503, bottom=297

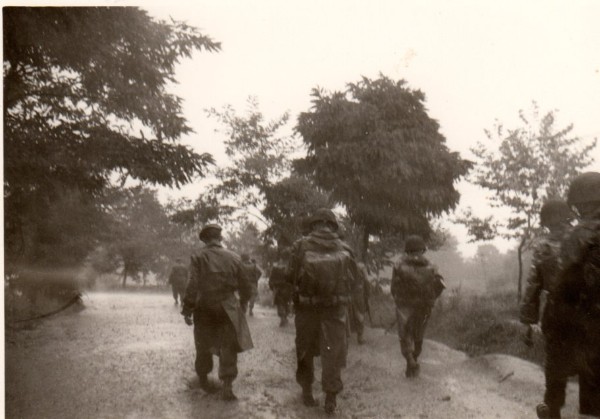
left=295, top=305, right=348, bottom=394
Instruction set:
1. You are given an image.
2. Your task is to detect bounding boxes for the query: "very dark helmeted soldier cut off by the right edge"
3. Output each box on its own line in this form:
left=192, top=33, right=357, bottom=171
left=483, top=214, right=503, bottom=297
left=537, top=172, right=600, bottom=418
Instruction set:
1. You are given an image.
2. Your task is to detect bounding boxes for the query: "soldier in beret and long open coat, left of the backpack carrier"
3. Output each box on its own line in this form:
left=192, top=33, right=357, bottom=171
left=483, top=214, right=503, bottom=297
left=181, top=224, right=253, bottom=401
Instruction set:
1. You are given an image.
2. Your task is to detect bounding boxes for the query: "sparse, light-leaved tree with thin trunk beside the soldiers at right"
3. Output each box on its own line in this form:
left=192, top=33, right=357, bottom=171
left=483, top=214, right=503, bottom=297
left=457, top=102, right=596, bottom=301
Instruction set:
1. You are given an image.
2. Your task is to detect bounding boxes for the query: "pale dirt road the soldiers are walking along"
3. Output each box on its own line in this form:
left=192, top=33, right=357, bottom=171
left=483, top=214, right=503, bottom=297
left=6, top=293, right=579, bottom=418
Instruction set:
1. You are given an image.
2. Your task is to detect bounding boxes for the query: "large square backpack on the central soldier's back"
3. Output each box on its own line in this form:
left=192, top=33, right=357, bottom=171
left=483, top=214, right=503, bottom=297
left=299, top=249, right=352, bottom=297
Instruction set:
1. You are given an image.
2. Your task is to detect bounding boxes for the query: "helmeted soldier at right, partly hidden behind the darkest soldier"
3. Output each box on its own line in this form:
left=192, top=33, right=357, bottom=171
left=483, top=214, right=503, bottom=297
left=520, top=200, right=574, bottom=338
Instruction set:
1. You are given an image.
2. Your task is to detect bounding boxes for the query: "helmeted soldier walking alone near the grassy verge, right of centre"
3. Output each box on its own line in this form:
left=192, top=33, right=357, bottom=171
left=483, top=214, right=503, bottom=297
left=391, top=235, right=446, bottom=377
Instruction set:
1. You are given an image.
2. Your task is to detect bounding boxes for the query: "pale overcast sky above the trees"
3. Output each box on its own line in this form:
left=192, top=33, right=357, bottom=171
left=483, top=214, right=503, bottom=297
left=11, top=0, right=600, bottom=255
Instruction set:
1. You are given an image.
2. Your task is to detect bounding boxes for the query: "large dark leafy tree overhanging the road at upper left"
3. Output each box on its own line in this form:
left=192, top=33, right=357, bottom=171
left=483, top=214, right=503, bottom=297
left=3, top=7, right=220, bottom=268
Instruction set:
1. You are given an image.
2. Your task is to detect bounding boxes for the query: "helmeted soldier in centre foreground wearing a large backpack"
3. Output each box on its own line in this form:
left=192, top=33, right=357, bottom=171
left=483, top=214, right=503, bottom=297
left=288, top=208, right=358, bottom=414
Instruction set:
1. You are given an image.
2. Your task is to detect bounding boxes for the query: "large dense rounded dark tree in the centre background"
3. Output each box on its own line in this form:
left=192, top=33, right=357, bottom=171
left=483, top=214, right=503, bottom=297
left=295, top=76, right=470, bottom=259
